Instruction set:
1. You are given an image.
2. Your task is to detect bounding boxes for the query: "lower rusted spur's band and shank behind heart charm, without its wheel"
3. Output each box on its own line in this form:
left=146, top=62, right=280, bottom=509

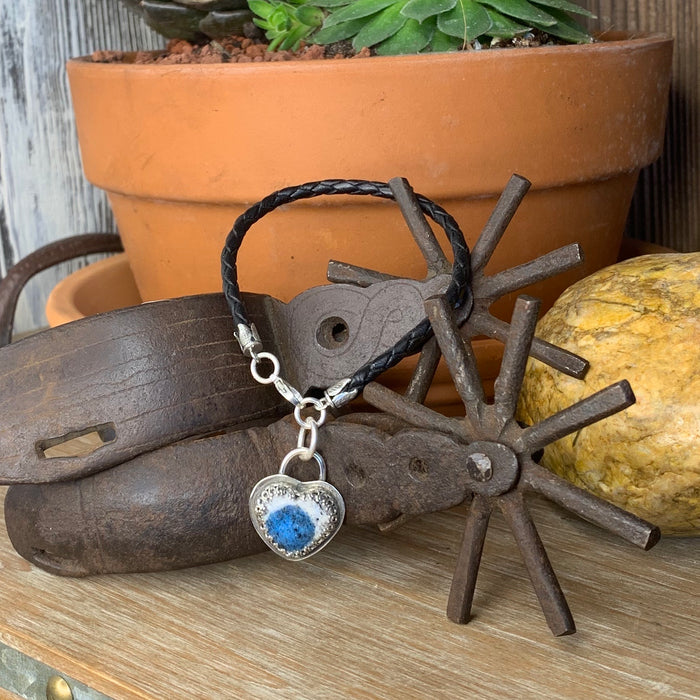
left=5, top=414, right=476, bottom=576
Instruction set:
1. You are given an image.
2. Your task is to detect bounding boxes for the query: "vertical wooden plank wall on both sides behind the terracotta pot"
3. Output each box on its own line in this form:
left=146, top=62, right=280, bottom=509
left=0, top=0, right=700, bottom=331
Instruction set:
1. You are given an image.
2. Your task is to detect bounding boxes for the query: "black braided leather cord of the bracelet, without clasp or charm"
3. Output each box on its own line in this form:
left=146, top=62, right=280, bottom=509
left=221, top=180, right=473, bottom=391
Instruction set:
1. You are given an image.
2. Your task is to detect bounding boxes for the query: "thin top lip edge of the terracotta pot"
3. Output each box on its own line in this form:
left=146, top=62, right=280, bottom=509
left=66, top=30, right=674, bottom=73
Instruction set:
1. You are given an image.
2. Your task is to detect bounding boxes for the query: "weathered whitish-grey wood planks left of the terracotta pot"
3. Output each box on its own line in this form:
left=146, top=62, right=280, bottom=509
left=0, top=0, right=162, bottom=332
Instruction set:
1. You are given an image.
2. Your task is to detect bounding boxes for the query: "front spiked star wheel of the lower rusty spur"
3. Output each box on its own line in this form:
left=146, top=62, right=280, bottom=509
left=364, top=296, right=659, bottom=636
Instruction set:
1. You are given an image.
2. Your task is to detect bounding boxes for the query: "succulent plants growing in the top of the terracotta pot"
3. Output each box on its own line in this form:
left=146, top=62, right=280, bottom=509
left=123, top=0, right=594, bottom=55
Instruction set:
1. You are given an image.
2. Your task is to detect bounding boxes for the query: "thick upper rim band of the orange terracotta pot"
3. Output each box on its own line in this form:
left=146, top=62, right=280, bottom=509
left=68, top=27, right=673, bottom=201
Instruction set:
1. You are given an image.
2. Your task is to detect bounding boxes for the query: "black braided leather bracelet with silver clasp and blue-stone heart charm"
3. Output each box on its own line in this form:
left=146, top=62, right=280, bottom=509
left=221, top=180, right=472, bottom=561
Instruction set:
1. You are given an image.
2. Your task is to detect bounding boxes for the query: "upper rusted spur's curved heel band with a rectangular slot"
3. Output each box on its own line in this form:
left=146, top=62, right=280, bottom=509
left=0, top=234, right=286, bottom=484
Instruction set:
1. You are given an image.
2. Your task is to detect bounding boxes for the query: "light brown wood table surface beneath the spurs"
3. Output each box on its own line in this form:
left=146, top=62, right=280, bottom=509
left=0, top=492, right=700, bottom=700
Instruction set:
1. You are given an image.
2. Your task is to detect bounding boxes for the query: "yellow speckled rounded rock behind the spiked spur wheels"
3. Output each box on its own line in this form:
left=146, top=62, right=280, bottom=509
left=518, top=253, right=700, bottom=535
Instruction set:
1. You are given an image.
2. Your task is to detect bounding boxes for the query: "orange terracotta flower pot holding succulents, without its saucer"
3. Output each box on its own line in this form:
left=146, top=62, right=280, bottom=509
left=68, top=35, right=672, bottom=313
